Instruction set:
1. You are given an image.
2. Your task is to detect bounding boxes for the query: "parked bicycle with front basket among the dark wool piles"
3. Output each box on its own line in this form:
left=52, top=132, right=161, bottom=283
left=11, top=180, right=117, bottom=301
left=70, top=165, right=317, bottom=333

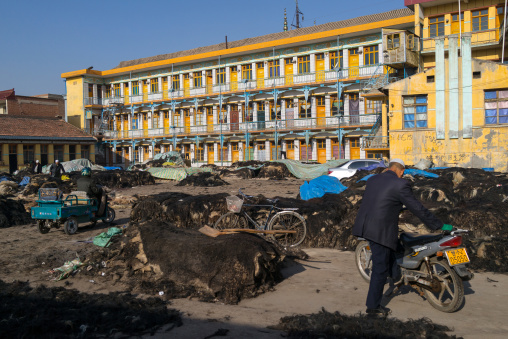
left=213, top=188, right=307, bottom=247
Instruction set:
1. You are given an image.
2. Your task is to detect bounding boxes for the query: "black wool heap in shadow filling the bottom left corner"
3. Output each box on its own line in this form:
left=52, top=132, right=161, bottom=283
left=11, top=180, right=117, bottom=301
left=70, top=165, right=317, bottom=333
left=0, top=280, right=182, bottom=338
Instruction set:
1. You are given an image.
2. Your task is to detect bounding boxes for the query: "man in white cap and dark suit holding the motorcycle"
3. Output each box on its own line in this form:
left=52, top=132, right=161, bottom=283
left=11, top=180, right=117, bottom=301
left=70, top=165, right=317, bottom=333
left=353, top=159, right=451, bottom=316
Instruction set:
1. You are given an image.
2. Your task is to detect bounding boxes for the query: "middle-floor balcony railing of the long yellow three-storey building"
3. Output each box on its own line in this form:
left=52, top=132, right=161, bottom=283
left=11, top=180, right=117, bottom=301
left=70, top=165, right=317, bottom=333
left=100, top=114, right=378, bottom=139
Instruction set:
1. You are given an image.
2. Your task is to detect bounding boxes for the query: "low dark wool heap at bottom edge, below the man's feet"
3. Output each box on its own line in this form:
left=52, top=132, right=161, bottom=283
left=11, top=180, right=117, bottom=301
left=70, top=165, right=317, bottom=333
left=274, top=309, right=457, bottom=339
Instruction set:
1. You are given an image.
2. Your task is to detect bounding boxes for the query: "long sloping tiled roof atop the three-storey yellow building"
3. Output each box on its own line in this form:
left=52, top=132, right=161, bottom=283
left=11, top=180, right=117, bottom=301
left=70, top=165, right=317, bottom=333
left=116, top=8, right=414, bottom=68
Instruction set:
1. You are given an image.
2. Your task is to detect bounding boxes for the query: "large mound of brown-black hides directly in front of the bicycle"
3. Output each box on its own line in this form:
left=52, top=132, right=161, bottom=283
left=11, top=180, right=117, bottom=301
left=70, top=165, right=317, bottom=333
left=97, top=220, right=285, bottom=304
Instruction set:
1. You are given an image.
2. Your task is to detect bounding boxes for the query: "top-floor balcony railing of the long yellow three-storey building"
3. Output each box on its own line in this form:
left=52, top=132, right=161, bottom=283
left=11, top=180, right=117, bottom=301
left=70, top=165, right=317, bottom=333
left=85, top=64, right=386, bottom=106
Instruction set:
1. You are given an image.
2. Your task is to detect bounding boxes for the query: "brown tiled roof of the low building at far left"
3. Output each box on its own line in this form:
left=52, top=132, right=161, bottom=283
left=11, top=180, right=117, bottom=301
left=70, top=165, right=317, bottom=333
left=0, top=115, right=96, bottom=142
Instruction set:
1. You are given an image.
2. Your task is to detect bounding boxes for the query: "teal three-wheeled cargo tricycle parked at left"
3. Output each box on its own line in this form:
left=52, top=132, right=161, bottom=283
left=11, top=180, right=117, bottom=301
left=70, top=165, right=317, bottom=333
left=31, top=188, right=115, bottom=235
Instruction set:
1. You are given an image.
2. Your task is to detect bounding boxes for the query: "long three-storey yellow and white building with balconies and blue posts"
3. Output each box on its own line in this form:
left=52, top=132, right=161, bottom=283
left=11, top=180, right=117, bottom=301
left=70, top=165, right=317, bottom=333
left=62, top=8, right=418, bottom=166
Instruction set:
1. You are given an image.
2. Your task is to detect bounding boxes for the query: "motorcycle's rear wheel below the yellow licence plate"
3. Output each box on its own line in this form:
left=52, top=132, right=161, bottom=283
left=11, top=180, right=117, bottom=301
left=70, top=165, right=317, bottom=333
left=421, top=258, right=464, bottom=313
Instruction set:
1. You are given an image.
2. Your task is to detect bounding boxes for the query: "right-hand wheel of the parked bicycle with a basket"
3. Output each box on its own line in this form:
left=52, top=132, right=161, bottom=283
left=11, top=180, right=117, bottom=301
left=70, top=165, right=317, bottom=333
left=268, top=211, right=307, bottom=247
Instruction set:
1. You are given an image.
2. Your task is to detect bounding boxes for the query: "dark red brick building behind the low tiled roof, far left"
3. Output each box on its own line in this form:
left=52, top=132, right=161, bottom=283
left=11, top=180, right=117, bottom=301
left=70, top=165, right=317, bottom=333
left=0, top=88, right=65, bottom=118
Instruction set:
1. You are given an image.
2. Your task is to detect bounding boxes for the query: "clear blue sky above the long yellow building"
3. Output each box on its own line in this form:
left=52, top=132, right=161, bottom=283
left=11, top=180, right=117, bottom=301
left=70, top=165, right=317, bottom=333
left=0, top=0, right=404, bottom=96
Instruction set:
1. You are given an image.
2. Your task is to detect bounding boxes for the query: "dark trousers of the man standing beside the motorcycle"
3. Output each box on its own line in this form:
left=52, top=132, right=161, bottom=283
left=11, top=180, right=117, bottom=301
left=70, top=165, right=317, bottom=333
left=366, top=241, right=397, bottom=308
